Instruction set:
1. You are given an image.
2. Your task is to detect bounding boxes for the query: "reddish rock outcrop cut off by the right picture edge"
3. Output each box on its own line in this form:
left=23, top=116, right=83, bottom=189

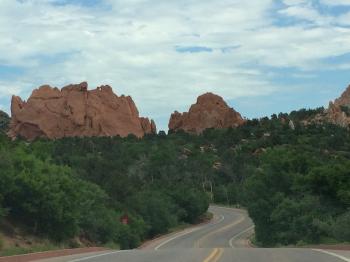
left=326, top=86, right=350, bottom=127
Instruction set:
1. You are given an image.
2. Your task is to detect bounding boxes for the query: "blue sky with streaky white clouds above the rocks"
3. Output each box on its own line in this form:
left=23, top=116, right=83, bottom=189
left=0, top=0, right=350, bottom=130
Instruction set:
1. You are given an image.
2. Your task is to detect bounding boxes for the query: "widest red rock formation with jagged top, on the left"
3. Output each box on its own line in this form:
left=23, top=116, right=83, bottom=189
left=9, top=82, right=156, bottom=140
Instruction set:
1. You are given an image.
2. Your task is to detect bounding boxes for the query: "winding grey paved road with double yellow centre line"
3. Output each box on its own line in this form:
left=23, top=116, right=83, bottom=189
left=41, top=206, right=350, bottom=262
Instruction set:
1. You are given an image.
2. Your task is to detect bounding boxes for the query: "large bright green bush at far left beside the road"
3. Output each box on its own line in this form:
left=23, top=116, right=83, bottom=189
left=0, top=148, right=116, bottom=242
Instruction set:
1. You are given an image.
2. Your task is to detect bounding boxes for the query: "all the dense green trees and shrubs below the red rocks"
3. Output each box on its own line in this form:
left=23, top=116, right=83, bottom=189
left=0, top=109, right=350, bottom=248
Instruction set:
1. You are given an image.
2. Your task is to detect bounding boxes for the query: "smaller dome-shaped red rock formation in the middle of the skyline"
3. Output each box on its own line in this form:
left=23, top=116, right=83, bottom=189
left=169, top=93, right=245, bottom=134
